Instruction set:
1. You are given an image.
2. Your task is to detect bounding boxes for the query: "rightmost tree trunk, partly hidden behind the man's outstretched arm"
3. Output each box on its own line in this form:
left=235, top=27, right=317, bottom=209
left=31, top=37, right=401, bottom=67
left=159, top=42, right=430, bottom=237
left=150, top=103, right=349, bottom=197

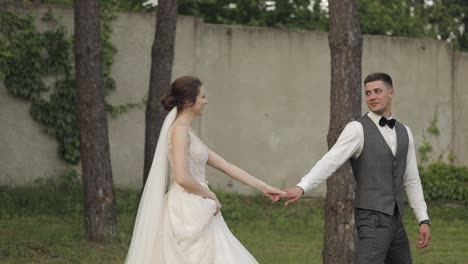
left=323, top=0, right=362, bottom=264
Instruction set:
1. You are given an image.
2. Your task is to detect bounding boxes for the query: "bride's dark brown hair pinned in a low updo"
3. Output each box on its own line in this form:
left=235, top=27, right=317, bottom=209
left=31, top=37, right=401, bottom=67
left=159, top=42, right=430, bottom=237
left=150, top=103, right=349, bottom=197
left=161, top=76, right=203, bottom=111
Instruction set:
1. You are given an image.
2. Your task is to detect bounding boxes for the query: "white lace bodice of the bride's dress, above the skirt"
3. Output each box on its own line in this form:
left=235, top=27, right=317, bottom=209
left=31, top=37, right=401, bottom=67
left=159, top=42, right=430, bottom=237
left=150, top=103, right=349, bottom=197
left=168, top=125, right=208, bottom=184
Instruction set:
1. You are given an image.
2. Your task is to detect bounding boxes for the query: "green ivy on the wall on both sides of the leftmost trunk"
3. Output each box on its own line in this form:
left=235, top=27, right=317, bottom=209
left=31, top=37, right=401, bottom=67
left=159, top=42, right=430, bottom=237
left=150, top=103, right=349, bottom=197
left=0, top=6, right=144, bottom=164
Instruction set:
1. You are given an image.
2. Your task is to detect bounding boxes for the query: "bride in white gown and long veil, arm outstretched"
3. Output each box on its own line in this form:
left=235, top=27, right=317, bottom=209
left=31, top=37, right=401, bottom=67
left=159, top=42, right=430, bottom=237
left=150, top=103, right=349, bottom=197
left=125, top=76, right=281, bottom=264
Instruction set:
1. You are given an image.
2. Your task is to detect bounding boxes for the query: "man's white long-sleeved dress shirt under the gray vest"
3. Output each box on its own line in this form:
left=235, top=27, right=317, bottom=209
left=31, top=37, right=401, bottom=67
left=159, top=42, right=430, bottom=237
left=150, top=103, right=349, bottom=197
left=297, top=112, right=429, bottom=222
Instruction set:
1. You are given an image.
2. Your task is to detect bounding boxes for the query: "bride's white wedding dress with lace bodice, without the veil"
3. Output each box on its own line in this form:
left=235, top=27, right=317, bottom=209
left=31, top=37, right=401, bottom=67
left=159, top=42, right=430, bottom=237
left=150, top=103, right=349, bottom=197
left=163, top=129, right=257, bottom=264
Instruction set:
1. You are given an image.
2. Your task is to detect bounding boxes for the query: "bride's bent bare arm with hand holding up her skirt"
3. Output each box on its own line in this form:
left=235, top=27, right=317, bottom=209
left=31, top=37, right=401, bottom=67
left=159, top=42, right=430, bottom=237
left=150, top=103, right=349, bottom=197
left=171, top=125, right=218, bottom=201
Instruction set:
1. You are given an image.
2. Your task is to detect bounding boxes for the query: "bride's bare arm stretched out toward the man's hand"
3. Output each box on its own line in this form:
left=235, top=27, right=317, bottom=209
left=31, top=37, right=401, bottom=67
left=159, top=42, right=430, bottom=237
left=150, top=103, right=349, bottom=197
left=208, top=149, right=281, bottom=200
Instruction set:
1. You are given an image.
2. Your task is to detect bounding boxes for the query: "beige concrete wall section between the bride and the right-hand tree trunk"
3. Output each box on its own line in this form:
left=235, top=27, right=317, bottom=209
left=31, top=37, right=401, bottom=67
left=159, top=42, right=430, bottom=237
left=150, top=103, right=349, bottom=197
left=197, top=25, right=330, bottom=196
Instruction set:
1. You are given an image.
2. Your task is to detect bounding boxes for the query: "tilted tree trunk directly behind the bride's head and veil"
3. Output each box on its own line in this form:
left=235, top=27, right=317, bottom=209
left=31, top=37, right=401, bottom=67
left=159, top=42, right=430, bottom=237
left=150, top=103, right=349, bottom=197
left=143, top=0, right=177, bottom=184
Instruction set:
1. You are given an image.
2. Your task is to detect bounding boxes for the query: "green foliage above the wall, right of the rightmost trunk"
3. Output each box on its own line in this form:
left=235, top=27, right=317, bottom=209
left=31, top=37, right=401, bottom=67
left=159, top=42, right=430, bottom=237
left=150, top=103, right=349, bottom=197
left=359, top=0, right=468, bottom=50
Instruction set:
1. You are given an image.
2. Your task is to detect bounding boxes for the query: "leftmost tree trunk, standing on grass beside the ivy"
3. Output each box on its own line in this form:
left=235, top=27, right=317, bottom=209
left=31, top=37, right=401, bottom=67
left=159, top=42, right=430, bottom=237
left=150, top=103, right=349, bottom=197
left=75, top=0, right=117, bottom=241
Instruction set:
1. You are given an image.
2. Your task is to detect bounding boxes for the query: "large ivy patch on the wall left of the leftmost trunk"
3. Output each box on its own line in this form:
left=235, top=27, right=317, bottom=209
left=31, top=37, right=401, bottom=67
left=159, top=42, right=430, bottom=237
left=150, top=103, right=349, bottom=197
left=0, top=11, right=79, bottom=164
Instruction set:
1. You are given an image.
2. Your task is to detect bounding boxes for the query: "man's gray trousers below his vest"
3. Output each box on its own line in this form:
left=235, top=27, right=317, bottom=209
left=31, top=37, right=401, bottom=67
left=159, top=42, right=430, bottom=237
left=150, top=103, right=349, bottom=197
left=354, top=208, right=412, bottom=264
